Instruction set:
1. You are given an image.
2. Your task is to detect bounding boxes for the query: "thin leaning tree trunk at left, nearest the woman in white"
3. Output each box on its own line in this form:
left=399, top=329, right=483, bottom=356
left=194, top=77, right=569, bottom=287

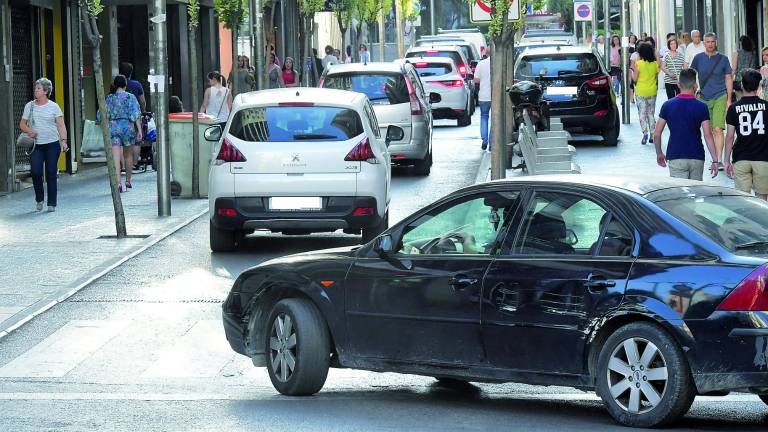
left=88, top=14, right=128, bottom=238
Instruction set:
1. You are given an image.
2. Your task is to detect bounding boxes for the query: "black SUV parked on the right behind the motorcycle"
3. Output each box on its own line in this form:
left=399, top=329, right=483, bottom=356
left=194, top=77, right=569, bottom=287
left=515, top=45, right=621, bottom=146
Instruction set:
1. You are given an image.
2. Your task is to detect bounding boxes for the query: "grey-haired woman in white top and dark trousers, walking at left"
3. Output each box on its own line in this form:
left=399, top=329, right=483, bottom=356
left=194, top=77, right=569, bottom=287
left=17, top=78, right=69, bottom=212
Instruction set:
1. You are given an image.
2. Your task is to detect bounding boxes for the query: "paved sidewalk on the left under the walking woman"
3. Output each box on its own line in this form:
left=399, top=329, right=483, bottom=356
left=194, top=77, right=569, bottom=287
left=0, top=166, right=208, bottom=337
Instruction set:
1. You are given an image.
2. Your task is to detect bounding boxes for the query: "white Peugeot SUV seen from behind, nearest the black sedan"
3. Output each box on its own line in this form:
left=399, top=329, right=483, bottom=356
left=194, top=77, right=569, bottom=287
left=205, top=88, right=403, bottom=252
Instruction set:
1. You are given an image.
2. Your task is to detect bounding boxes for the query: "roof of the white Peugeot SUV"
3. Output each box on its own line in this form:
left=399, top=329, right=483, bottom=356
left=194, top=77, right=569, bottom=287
left=234, top=87, right=368, bottom=107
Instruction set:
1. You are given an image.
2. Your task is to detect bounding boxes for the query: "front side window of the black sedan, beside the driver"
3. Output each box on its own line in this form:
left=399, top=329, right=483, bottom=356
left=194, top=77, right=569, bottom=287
left=398, top=191, right=520, bottom=255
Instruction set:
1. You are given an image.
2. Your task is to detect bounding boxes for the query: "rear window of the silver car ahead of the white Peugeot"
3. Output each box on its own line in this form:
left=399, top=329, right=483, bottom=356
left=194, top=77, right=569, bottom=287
left=323, top=72, right=409, bottom=105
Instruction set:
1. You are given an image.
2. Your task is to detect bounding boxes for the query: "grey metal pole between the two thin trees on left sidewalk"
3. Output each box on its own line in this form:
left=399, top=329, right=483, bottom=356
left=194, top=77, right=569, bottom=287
left=150, top=0, right=171, bottom=216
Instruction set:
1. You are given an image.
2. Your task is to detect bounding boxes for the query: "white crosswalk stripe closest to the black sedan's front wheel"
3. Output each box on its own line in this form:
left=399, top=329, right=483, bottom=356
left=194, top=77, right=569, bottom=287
left=142, top=320, right=236, bottom=378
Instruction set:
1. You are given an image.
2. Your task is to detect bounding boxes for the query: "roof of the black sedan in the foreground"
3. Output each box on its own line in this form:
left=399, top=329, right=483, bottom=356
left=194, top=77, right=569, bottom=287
left=480, top=174, right=737, bottom=195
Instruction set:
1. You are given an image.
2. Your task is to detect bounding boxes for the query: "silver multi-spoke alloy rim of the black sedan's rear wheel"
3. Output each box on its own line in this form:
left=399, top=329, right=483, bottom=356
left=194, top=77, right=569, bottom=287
left=606, top=337, right=669, bottom=414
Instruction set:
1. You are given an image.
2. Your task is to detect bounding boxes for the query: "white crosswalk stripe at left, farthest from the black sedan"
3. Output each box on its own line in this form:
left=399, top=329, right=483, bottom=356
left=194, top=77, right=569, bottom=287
left=0, top=320, right=130, bottom=378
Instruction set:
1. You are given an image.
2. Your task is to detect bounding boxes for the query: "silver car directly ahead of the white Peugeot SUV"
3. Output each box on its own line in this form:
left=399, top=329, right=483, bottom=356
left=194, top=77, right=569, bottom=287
left=319, top=62, right=440, bottom=175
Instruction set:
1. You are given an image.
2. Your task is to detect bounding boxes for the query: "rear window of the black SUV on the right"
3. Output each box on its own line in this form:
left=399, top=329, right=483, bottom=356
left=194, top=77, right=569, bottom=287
left=515, top=53, right=600, bottom=79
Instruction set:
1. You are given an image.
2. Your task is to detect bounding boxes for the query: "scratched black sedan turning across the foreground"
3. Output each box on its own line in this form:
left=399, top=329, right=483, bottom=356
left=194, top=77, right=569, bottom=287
left=223, top=175, right=768, bottom=427
